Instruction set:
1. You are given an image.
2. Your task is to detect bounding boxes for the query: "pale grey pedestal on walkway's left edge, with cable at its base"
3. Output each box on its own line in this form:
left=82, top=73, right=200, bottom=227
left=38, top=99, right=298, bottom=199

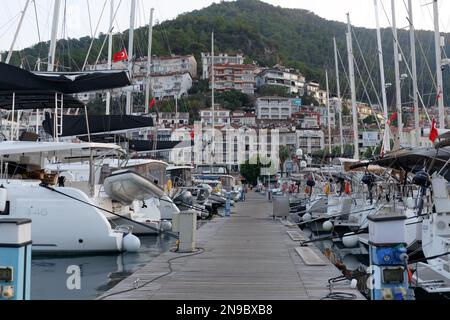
left=172, top=210, right=197, bottom=253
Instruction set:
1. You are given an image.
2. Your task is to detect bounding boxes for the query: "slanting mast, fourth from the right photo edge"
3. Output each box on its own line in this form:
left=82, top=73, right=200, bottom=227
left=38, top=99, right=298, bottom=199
left=373, top=0, right=391, bottom=152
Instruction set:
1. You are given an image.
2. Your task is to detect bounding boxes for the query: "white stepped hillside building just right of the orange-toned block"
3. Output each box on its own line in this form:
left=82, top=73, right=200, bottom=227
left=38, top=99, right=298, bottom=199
left=256, top=65, right=306, bottom=96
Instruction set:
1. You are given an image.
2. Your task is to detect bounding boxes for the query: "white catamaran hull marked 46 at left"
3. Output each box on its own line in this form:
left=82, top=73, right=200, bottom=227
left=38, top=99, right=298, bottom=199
left=0, top=180, right=124, bottom=254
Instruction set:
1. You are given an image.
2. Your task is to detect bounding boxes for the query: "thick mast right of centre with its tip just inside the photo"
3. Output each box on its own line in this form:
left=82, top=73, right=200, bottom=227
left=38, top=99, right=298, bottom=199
left=347, top=13, right=359, bottom=160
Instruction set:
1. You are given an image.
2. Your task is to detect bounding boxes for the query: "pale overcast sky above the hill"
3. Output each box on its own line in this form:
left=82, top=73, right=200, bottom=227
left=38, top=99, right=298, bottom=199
left=0, top=0, right=450, bottom=50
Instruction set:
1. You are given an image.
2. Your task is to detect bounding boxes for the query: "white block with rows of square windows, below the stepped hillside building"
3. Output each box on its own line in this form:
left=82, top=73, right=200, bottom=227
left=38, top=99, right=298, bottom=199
left=256, top=97, right=292, bottom=120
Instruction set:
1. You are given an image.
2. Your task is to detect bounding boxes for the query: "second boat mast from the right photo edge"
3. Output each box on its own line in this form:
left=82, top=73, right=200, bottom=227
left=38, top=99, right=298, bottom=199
left=408, top=0, right=420, bottom=146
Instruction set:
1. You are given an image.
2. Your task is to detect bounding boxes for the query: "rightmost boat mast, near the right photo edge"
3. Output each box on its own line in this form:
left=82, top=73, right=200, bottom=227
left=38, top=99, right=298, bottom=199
left=433, top=0, right=446, bottom=129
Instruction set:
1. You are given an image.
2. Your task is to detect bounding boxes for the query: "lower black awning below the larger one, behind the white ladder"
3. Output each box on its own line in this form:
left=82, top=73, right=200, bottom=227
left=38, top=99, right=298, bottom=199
left=43, top=113, right=153, bottom=137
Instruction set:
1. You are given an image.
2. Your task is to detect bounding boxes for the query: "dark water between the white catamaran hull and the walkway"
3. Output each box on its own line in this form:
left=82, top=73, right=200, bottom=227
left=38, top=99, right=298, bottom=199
left=31, top=236, right=176, bottom=300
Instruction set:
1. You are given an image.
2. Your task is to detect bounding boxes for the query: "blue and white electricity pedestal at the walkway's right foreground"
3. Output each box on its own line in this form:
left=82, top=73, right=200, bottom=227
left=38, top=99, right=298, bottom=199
left=368, top=214, right=414, bottom=300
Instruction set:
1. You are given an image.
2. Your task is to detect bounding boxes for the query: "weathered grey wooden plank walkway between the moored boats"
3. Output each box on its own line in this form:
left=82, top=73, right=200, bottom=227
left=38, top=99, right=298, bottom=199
left=100, top=193, right=364, bottom=300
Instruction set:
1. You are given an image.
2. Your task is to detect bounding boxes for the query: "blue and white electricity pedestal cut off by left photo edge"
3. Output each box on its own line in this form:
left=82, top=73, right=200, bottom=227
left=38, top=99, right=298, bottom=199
left=0, top=219, right=31, bottom=300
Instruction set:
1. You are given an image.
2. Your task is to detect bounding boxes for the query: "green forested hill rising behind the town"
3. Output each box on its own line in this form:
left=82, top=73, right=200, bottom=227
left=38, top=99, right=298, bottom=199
left=4, top=0, right=450, bottom=104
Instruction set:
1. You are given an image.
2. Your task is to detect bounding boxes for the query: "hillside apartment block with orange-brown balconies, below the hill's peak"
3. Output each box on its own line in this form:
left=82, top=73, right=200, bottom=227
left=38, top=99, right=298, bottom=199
left=209, top=64, right=256, bottom=95
